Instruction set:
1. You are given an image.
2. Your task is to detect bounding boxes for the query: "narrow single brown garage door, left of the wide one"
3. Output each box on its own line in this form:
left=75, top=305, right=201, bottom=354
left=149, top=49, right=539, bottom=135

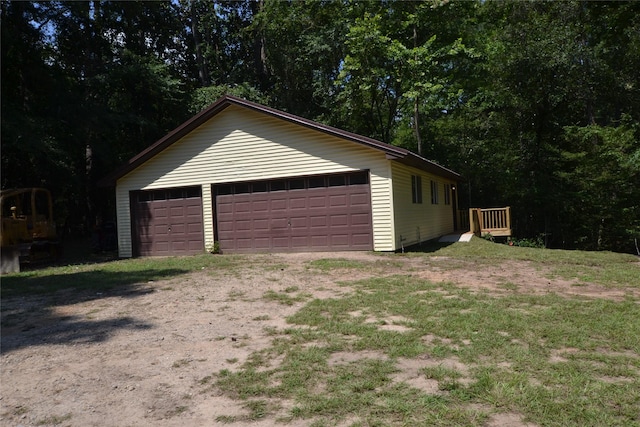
left=131, top=187, right=204, bottom=256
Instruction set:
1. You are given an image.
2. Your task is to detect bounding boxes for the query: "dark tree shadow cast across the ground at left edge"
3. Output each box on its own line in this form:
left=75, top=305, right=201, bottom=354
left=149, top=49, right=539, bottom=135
left=0, top=268, right=188, bottom=354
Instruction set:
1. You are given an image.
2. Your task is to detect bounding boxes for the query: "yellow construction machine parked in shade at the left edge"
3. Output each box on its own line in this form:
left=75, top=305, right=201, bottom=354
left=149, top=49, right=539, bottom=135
left=0, top=188, right=60, bottom=274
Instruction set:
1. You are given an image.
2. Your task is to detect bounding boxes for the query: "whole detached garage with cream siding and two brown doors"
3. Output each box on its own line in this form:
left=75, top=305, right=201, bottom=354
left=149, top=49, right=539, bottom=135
left=102, top=96, right=460, bottom=257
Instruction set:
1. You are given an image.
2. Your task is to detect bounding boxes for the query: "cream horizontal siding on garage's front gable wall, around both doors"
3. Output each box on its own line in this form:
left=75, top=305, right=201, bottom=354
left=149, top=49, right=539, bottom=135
left=116, top=106, right=394, bottom=257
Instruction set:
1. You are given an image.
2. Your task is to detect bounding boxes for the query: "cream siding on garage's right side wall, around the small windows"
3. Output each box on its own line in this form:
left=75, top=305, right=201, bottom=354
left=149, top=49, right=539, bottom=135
left=391, top=162, right=455, bottom=248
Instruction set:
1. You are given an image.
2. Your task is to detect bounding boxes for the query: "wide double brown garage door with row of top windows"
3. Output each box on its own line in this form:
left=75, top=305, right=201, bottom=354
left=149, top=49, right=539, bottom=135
left=214, top=172, right=373, bottom=253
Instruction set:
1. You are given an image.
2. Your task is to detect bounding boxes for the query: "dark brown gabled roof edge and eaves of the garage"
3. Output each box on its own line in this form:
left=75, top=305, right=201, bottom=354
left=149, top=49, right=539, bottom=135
left=98, top=95, right=461, bottom=187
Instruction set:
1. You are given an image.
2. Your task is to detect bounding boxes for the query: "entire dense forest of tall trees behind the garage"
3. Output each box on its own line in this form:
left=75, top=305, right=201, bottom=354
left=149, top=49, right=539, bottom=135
left=1, top=0, right=640, bottom=253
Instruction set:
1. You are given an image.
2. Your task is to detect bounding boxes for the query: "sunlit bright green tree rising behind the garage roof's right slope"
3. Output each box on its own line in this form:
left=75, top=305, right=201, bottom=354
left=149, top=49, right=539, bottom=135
left=336, top=1, right=474, bottom=150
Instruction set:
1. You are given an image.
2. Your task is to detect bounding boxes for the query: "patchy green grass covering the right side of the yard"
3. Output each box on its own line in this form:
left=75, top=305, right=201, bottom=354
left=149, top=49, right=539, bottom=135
left=208, top=241, right=640, bottom=426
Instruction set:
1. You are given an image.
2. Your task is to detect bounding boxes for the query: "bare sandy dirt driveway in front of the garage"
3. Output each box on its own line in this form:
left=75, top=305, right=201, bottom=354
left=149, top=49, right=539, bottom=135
left=0, top=253, right=637, bottom=427
